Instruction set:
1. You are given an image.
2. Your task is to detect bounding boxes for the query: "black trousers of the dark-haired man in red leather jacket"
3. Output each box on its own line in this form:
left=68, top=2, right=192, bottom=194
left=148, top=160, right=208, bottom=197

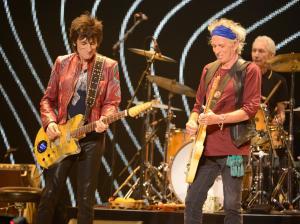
left=37, top=133, right=105, bottom=224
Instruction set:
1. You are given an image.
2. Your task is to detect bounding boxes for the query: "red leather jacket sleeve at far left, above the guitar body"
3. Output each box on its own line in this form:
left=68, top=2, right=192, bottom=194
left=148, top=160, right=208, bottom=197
left=40, top=58, right=60, bottom=130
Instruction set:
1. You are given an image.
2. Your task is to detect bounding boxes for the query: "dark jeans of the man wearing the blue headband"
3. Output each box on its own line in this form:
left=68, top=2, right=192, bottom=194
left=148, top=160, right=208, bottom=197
left=184, top=156, right=245, bottom=224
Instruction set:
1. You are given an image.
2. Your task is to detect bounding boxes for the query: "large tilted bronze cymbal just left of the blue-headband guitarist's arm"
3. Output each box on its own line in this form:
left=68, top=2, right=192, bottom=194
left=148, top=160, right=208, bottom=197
left=147, top=75, right=196, bottom=97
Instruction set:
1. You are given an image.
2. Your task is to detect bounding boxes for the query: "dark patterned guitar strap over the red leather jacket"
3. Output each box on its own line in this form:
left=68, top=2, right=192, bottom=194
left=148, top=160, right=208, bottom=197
left=84, top=55, right=105, bottom=121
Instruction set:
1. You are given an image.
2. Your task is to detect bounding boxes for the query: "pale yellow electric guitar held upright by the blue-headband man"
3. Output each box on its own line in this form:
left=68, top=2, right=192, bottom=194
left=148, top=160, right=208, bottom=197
left=185, top=76, right=220, bottom=184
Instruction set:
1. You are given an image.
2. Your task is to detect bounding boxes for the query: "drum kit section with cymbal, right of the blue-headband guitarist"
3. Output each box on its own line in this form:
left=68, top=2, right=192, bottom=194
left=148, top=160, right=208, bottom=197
left=242, top=53, right=300, bottom=212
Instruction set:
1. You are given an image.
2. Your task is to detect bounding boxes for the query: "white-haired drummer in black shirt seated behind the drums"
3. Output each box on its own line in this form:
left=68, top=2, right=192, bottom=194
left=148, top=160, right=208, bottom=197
left=251, top=36, right=289, bottom=126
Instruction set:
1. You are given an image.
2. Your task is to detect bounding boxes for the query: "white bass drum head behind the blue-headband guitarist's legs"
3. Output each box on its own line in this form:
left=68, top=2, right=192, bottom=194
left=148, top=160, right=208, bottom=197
left=168, top=142, right=224, bottom=212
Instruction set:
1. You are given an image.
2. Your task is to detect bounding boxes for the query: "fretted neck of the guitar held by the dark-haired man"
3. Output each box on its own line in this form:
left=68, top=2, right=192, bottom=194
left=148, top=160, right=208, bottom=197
left=71, top=110, right=127, bottom=138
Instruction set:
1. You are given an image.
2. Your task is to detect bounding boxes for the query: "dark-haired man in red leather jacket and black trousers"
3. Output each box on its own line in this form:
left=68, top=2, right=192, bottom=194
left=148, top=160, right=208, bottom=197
left=37, top=14, right=121, bottom=224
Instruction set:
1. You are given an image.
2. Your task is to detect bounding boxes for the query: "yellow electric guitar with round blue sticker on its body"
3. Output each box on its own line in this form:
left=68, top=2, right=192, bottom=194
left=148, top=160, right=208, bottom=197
left=34, top=100, right=158, bottom=168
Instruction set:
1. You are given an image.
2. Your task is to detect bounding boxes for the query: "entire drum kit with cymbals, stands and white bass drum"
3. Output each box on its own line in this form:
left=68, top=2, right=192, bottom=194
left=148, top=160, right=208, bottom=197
left=113, top=48, right=300, bottom=211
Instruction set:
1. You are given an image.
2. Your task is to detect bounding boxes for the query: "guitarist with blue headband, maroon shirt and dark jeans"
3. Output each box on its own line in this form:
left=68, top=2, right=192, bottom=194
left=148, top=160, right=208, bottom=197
left=184, top=18, right=261, bottom=224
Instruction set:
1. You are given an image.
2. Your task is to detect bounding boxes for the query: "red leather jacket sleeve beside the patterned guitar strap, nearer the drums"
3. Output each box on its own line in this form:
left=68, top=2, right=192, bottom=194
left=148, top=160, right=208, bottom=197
left=101, top=62, right=121, bottom=116
